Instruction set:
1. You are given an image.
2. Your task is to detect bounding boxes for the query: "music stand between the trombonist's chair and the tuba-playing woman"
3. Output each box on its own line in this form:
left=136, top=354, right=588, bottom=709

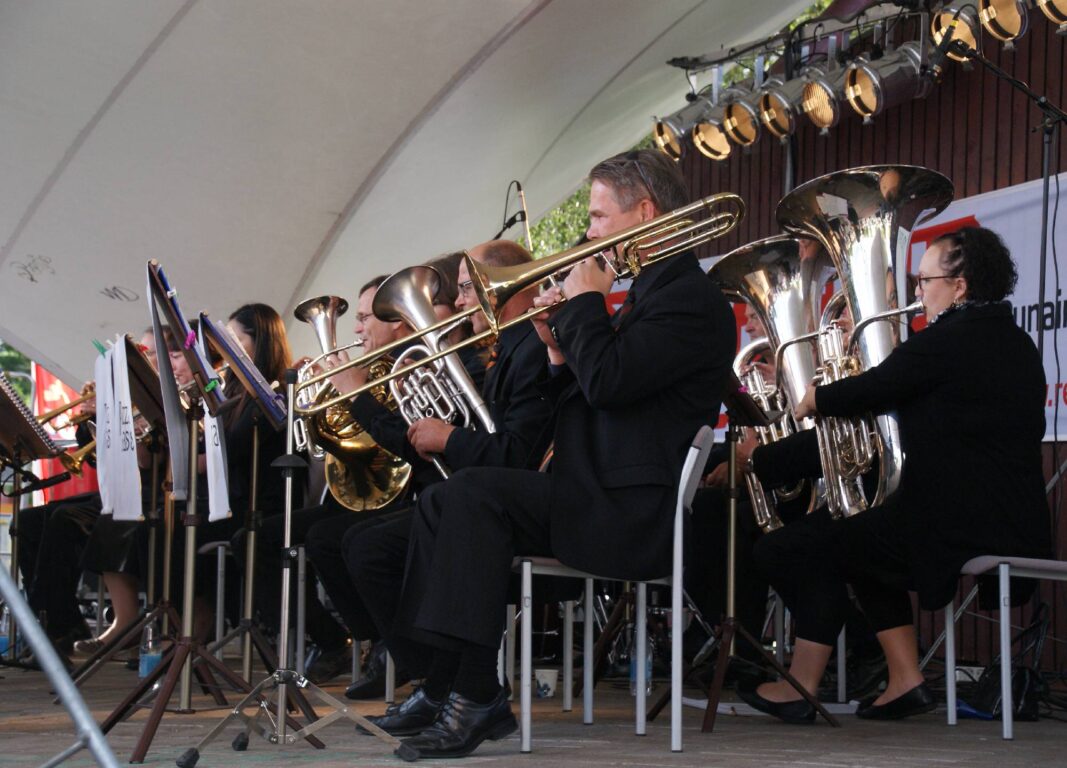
left=701, top=373, right=841, bottom=733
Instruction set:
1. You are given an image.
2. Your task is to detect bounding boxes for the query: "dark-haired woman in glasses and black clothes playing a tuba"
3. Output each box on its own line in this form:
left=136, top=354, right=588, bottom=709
left=743, top=227, right=1052, bottom=722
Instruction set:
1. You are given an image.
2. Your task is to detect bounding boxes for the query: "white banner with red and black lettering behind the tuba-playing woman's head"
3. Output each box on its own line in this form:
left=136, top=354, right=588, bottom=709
left=905, top=173, right=1067, bottom=441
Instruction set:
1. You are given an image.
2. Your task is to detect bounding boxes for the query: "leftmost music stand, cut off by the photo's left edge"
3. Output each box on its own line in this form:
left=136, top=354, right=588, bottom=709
left=0, top=371, right=70, bottom=669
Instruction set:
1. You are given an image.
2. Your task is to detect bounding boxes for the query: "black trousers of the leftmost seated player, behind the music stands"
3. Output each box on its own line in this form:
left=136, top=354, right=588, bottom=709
left=15, top=494, right=100, bottom=638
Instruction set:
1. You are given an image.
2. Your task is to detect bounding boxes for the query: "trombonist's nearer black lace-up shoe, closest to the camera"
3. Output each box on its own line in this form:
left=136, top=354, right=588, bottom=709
left=396, top=689, right=519, bottom=763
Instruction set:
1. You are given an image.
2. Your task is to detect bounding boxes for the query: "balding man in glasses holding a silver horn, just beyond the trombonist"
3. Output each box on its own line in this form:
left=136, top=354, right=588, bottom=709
left=343, top=240, right=553, bottom=704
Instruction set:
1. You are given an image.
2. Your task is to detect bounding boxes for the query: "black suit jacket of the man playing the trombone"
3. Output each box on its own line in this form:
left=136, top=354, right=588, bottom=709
left=548, top=254, right=736, bottom=579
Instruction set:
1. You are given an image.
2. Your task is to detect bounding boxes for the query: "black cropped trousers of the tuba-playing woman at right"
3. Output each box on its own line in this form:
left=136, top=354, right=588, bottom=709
left=754, top=497, right=913, bottom=645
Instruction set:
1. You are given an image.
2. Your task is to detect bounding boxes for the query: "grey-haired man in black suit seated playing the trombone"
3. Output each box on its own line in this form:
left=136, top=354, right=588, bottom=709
left=367, top=150, right=736, bottom=759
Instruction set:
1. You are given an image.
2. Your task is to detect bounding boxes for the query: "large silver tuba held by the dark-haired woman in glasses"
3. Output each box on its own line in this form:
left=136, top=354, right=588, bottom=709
left=777, top=165, right=953, bottom=516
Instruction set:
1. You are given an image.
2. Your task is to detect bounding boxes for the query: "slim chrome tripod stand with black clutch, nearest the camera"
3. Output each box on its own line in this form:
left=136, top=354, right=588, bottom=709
left=177, top=368, right=400, bottom=768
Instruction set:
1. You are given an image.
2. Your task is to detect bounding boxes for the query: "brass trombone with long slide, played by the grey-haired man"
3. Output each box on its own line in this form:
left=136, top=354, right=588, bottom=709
left=293, top=192, right=745, bottom=416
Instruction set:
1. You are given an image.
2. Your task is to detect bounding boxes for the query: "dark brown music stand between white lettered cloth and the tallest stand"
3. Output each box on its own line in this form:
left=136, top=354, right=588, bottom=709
left=65, top=336, right=180, bottom=691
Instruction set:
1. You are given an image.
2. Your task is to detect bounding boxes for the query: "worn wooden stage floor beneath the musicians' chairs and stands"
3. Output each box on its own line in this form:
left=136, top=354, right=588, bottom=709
left=0, top=663, right=1067, bottom=768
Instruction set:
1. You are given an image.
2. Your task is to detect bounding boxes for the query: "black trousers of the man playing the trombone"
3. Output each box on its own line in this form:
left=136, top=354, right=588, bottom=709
left=394, top=467, right=552, bottom=650
